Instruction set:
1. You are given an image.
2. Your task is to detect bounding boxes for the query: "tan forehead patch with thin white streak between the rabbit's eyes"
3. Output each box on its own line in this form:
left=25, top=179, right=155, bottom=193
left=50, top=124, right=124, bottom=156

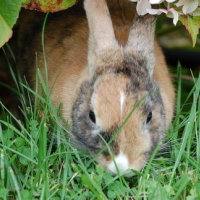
left=91, top=76, right=147, bottom=130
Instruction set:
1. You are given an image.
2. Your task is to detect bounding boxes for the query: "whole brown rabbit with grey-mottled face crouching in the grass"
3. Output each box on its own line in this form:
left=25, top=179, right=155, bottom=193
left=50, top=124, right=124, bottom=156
left=16, top=0, right=175, bottom=177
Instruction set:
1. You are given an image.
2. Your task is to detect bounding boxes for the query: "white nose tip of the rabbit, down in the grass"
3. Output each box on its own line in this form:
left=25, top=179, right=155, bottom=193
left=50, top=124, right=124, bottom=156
left=107, top=152, right=134, bottom=177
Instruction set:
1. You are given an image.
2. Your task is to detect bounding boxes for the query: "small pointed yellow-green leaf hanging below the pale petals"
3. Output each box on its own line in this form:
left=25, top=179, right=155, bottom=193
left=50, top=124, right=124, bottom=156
left=180, top=15, right=200, bottom=47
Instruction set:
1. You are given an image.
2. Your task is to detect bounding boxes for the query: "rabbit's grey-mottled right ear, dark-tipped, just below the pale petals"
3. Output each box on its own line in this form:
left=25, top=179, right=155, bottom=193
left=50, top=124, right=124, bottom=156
left=125, top=13, right=156, bottom=75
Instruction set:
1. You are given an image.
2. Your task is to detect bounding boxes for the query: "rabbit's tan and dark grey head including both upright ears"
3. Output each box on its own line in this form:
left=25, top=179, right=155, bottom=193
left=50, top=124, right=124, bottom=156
left=72, top=0, right=166, bottom=176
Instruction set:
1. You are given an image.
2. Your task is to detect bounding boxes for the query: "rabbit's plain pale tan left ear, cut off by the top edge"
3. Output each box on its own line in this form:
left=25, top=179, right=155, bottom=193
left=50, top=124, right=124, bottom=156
left=84, top=0, right=118, bottom=74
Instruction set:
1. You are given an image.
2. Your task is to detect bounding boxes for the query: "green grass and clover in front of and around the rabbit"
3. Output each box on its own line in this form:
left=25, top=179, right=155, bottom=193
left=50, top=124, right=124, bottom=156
left=0, top=21, right=200, bottom=200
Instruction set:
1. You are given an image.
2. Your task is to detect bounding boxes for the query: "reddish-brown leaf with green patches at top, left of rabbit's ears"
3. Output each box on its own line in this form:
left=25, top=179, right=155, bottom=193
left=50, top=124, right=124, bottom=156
left=22, top=0, right=76, bottom=13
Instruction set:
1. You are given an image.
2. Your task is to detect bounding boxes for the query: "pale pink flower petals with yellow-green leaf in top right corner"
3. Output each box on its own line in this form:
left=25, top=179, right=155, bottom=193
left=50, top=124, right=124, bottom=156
left=131, top=0, right=200, bottom=47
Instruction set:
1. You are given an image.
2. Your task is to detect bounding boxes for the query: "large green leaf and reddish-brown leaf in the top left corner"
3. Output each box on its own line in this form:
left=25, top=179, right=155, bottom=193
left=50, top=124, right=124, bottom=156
left=0, top=0, right=76, bottom=47
